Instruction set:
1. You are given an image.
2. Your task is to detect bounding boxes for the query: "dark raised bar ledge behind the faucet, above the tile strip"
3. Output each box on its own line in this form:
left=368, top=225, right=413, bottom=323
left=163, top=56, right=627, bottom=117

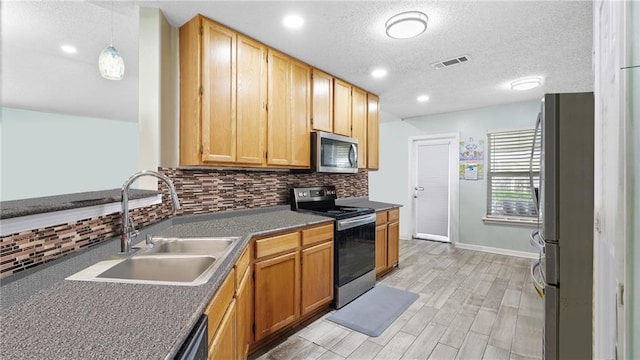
left=0, top=189, right=160, bottom=219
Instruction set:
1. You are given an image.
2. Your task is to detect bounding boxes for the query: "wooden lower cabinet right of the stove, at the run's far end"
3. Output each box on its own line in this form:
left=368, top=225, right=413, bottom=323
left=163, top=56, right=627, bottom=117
left=375, top=208, right=400, bottom=276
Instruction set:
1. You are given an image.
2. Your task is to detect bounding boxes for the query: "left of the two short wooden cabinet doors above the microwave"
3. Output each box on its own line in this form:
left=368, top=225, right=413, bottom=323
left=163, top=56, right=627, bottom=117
left=311, top=69, right=333, bottom=132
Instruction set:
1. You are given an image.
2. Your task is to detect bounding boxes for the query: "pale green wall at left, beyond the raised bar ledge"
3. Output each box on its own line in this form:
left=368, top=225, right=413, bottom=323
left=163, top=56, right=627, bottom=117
left=0, top=107, right=138, bottom=201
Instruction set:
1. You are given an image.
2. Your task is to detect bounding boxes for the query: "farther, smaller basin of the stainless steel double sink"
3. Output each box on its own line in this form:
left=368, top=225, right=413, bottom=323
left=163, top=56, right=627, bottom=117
left=145, top=237, right=238, bottom=254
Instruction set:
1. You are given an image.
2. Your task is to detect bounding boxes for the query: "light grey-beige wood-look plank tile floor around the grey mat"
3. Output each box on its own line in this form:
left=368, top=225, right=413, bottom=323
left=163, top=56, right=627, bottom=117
left=250, top=240, right=544, bottom=360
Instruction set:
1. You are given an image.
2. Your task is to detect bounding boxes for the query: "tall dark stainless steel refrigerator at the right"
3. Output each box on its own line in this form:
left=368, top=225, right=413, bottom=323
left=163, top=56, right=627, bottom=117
left=531, top=92, right=594, bottom=359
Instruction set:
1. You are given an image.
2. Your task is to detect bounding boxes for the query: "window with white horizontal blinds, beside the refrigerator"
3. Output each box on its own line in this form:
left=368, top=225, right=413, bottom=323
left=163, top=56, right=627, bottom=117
left=487, top=129, right=540, bottom=220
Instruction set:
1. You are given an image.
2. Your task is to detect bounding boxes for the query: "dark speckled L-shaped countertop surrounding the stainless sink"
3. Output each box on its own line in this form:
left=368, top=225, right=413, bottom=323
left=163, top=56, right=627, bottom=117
left=0, top=206, right=333, bottom=359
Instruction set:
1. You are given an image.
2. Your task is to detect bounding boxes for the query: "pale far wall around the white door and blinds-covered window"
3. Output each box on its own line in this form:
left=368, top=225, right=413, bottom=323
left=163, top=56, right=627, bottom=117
left=369, top=101, right=540, bottom=253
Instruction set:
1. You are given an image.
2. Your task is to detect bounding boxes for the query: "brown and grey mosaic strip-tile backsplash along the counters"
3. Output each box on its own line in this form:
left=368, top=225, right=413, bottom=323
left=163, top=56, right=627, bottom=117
left=0, top=168, right=368, bottom=279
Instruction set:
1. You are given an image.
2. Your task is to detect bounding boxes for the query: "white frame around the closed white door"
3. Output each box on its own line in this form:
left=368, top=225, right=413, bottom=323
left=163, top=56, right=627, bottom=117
left=407, top=133, right=460, bottom=244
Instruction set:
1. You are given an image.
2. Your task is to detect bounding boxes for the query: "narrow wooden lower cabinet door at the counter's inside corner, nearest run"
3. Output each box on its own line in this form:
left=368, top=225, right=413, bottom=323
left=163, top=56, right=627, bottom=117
left=236, top=268, right=253, bottom=360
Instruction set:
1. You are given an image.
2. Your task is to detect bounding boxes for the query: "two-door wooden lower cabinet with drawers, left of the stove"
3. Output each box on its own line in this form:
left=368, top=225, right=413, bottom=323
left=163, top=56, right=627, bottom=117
left=251, top=223, right=333, bottom=351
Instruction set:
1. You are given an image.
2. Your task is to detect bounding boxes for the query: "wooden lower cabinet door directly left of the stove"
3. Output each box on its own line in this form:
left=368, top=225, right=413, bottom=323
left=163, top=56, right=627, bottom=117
left=302, top=241, right=333, bottom=315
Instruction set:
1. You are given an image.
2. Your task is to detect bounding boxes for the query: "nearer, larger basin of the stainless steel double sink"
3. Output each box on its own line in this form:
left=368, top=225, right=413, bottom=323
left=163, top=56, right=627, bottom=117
left=67, top=254, right=219, bottom=286
